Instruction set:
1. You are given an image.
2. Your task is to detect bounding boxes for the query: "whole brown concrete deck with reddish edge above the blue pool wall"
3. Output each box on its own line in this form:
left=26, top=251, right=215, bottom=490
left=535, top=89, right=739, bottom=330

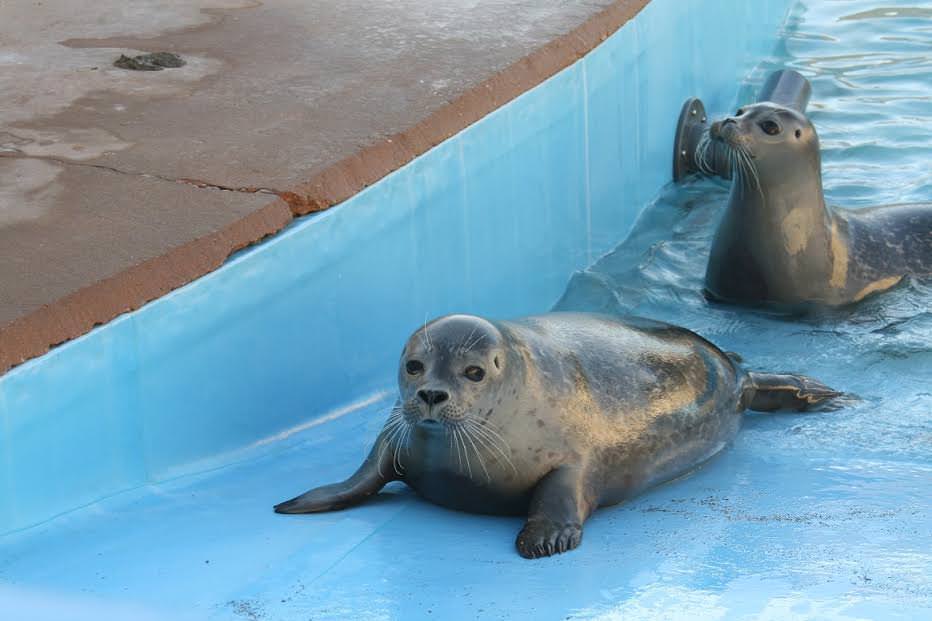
left=0, top=0, right=647, bottom=372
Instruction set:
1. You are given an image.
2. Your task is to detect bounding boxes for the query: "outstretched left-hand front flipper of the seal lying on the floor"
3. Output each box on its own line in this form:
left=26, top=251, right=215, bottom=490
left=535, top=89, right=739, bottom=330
left=275, top=434, right=399, bottom=513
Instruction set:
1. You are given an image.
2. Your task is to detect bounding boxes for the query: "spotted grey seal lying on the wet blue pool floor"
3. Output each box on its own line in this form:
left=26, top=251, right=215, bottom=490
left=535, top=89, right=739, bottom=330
left=275, top=313, right=840, bottom=558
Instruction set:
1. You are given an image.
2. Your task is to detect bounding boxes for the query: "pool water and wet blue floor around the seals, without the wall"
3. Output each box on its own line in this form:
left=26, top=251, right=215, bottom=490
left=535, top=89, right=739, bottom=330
left=0, top=0, right=932, bottom=621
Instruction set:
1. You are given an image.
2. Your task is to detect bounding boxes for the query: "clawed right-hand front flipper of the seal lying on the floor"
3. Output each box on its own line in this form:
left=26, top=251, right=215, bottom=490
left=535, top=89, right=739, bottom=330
left=515, top=466, right=596, bottom=558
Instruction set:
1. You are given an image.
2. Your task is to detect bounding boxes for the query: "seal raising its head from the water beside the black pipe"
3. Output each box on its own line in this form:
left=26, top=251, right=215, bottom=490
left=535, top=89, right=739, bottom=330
left=699, top=102, right=932, bottom=310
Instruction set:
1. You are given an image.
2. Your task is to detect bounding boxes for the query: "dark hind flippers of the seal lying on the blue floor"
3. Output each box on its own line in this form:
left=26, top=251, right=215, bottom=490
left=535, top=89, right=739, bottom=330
left=744, top=373, right=844, bottom=412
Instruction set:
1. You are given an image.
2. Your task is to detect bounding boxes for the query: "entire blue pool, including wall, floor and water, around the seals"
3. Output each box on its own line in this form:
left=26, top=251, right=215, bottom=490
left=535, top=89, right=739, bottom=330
left=0, top=0, right=932, bottom=620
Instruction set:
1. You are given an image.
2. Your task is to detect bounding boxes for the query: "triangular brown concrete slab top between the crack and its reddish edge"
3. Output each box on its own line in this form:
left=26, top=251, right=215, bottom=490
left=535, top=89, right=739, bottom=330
left=0, top=158, right=284, bottom=325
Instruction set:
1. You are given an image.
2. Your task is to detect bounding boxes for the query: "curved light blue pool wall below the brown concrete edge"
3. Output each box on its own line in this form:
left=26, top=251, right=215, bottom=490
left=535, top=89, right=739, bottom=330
left=0, top=0, right=791, bottom=534
